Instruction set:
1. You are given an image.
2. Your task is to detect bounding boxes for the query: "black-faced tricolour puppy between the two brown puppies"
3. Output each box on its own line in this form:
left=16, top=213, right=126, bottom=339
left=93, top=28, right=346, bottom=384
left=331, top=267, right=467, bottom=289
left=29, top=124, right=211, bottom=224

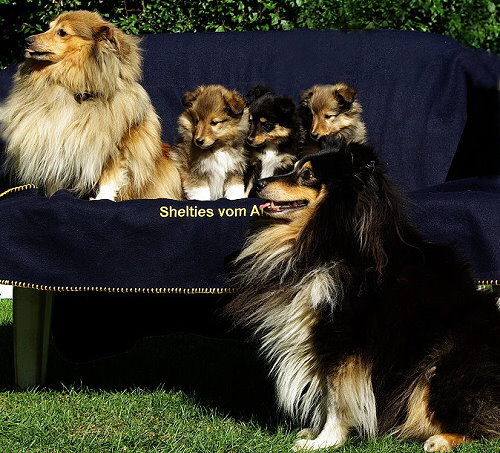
left=246, top=86, right=305, bottom=191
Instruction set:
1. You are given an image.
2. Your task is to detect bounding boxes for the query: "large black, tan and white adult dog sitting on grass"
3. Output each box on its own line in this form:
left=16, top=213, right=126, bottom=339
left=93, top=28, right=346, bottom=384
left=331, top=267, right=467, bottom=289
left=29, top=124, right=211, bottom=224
left=227, top=140, right=500, bottom=452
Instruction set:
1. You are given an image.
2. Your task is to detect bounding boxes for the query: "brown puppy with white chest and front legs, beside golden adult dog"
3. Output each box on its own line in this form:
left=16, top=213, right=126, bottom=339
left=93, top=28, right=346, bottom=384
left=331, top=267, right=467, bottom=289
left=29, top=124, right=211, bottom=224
left=172, top=85, right=248, bottom=200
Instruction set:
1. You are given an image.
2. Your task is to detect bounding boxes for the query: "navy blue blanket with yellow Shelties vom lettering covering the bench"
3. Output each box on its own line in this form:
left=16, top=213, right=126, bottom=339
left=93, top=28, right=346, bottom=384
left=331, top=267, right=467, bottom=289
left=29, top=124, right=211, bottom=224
left=0, top=31, right=500, bottom=291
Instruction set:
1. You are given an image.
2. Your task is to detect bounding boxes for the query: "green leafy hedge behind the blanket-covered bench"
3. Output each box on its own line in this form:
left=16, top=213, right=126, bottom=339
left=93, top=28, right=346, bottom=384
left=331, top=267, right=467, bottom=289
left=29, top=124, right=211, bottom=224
left=0, top=0, right=500, bottom=67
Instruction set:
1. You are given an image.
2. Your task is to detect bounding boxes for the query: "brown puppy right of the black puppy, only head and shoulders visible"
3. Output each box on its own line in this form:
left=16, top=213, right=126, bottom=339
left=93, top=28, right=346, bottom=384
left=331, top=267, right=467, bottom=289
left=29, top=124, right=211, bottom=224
left=300, top=83, right=366, bottom=155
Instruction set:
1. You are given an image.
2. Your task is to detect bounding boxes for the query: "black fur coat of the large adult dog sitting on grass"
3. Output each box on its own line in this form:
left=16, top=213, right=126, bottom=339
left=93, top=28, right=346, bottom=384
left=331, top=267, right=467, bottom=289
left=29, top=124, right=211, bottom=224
left=228, top=143, right=500, bottom=444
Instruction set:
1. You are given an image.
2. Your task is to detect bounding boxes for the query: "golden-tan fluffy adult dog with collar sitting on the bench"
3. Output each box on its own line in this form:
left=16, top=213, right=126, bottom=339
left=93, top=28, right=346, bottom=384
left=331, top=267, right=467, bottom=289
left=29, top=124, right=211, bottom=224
left=0, top=11, right=182, bottom=200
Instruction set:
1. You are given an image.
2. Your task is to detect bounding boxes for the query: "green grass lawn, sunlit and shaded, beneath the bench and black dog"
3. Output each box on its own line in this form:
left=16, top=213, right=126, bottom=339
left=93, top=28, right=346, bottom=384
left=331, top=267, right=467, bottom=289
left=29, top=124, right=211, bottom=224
left=0, top=301, right=500, bottom=453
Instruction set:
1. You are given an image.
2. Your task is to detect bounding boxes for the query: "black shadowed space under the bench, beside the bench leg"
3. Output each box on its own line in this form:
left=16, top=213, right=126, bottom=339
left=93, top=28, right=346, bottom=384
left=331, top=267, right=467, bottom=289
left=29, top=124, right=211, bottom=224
left=48, top=293, right=279, bottom=427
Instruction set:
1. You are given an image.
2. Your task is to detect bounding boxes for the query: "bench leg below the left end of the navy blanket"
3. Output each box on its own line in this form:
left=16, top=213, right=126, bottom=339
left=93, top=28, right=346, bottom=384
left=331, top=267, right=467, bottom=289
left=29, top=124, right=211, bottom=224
left=13, top=287, right=52, bottom=390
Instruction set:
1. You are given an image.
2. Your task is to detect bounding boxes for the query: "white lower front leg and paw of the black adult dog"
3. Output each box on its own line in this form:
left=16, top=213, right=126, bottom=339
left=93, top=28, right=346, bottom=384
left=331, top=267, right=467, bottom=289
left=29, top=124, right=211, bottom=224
left=293, top=389, right=349, bottom=451
